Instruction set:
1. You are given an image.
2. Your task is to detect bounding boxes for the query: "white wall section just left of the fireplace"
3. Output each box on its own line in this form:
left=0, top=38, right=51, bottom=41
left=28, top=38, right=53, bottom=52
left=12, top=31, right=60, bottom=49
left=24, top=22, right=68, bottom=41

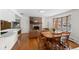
left=20, top=17, right=29, bottom=33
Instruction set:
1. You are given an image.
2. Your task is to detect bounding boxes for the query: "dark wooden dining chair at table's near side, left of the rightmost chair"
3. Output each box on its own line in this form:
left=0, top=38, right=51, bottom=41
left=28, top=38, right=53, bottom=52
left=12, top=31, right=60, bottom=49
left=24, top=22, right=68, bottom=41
left=52, top=33, right=63, bottom=50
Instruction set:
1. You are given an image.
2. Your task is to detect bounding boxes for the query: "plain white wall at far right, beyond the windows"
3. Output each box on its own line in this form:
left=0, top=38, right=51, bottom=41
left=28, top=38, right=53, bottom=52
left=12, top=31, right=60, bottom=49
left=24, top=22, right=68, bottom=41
left=71, top=10, right=79, bottom=43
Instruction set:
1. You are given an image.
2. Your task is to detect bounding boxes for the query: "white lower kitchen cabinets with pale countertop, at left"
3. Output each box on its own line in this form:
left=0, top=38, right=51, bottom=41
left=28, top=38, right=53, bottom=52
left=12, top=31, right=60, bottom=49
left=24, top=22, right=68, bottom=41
left=0, top=32, right=18, bottom=50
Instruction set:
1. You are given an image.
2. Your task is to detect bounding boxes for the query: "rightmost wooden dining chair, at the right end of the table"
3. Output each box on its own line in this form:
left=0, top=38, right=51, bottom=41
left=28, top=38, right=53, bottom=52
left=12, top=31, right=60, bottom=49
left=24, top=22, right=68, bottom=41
left=61, top=32, right=70, bottom=49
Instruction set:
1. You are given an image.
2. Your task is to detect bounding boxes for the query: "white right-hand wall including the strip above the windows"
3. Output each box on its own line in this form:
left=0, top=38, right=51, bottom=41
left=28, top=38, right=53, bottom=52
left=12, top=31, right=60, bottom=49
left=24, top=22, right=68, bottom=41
left=54, top=10, right=79, bottom=43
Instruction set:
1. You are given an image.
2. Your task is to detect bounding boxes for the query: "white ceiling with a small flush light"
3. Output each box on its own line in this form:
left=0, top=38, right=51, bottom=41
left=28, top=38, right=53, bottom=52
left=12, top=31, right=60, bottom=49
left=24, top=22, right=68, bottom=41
left=16, top=9, right=71, bottom=16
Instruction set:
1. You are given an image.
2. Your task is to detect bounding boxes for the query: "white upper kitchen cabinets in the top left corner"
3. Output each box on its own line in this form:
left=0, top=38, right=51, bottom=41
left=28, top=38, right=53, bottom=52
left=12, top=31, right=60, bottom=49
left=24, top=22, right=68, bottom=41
left=0, top=9, right=15, bottom=22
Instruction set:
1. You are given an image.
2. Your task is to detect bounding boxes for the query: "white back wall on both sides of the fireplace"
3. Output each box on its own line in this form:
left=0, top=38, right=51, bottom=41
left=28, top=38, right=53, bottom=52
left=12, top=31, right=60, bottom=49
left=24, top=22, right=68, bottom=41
left=20, top=16, right=52, bottom=33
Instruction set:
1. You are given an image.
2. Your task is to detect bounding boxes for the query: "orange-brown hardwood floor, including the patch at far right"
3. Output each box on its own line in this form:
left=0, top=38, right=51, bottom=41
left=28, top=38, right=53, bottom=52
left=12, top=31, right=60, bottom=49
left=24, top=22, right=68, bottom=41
left=13, top=34, right=79, bottom=50
